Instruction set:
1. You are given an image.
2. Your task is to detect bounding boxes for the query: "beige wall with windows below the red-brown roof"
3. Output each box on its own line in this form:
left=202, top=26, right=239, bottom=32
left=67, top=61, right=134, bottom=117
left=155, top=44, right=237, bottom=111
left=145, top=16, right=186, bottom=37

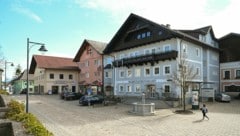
left=33, top=68, right=79, bottom=94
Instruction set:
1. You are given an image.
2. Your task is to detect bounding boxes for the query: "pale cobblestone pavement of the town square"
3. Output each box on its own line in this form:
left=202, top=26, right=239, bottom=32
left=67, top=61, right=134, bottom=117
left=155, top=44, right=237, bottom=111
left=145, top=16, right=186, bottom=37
left=11, top=95, right=240, bottom=136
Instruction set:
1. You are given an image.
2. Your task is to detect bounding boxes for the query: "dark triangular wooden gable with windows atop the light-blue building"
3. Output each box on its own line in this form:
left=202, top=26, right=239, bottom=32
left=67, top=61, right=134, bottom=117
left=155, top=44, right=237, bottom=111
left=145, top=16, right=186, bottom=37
left=104, top=14, right=179, bottom=53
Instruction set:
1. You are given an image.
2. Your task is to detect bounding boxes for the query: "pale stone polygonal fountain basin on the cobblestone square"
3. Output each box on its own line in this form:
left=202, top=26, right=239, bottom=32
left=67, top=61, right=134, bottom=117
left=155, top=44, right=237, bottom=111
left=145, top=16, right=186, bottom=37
left=130, top=102, right=155, bottom=116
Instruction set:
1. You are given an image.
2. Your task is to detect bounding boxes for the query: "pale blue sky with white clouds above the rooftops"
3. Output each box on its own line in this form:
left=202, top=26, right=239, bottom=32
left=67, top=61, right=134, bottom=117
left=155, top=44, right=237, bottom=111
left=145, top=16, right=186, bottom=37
left=0, top=0, right=240, bottom=80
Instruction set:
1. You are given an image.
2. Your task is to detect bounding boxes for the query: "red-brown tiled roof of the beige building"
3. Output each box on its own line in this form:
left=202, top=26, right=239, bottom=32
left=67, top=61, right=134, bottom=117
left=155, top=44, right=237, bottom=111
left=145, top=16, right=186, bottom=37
left=29, top=55, right=79, bottom=74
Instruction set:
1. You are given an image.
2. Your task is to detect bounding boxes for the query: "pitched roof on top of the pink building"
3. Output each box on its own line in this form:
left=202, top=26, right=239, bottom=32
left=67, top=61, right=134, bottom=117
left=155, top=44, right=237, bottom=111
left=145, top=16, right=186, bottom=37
left=73, top=39, right=107, bottom=62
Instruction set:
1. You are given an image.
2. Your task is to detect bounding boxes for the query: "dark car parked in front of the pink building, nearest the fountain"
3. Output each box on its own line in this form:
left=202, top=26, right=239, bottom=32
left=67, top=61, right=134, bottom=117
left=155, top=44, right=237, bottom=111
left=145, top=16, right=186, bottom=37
left=79, top=95, right=104, bottom=105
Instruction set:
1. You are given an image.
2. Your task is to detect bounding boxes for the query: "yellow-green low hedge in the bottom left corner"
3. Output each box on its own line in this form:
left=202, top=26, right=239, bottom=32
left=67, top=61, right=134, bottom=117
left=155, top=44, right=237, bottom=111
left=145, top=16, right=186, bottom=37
left=5, top=100, right=53, bottom=136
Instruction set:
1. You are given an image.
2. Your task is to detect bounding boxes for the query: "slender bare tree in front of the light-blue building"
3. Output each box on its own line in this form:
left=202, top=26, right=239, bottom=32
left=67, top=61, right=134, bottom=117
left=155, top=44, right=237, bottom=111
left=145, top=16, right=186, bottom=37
left=171, top=55, right=200, bottom=111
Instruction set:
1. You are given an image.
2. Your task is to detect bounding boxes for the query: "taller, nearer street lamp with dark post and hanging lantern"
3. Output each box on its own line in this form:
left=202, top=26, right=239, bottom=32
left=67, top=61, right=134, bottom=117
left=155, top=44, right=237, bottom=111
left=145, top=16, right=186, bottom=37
left=26, top=38, right=47, bottom=113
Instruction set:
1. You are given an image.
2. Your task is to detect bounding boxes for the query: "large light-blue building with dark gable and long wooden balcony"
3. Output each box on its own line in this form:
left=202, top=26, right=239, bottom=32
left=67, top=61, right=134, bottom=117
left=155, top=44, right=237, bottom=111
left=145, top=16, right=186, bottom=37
left=104, top=14, right=219, bottom=98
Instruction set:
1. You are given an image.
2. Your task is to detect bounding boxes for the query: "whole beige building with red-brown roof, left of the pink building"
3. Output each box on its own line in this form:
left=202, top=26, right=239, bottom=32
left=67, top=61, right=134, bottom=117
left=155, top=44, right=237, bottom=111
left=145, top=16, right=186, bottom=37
left=29, top=55, right=79, bottom=94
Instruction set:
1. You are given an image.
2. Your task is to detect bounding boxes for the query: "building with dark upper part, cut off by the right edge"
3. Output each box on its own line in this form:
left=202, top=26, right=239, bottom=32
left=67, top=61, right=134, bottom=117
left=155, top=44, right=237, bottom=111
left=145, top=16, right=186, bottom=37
left=219, top=33, right=240, bottom=96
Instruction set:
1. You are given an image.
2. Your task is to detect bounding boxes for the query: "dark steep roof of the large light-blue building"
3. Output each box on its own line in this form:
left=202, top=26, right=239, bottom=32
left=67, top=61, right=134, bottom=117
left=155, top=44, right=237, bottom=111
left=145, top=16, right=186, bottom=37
left=103, top=13, right=218, bottom=54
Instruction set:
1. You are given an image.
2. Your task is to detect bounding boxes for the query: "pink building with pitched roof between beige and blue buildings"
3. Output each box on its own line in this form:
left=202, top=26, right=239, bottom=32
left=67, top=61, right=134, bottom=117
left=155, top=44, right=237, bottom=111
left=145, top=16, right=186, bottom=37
left=73, top=40, right=106, bottom=94
